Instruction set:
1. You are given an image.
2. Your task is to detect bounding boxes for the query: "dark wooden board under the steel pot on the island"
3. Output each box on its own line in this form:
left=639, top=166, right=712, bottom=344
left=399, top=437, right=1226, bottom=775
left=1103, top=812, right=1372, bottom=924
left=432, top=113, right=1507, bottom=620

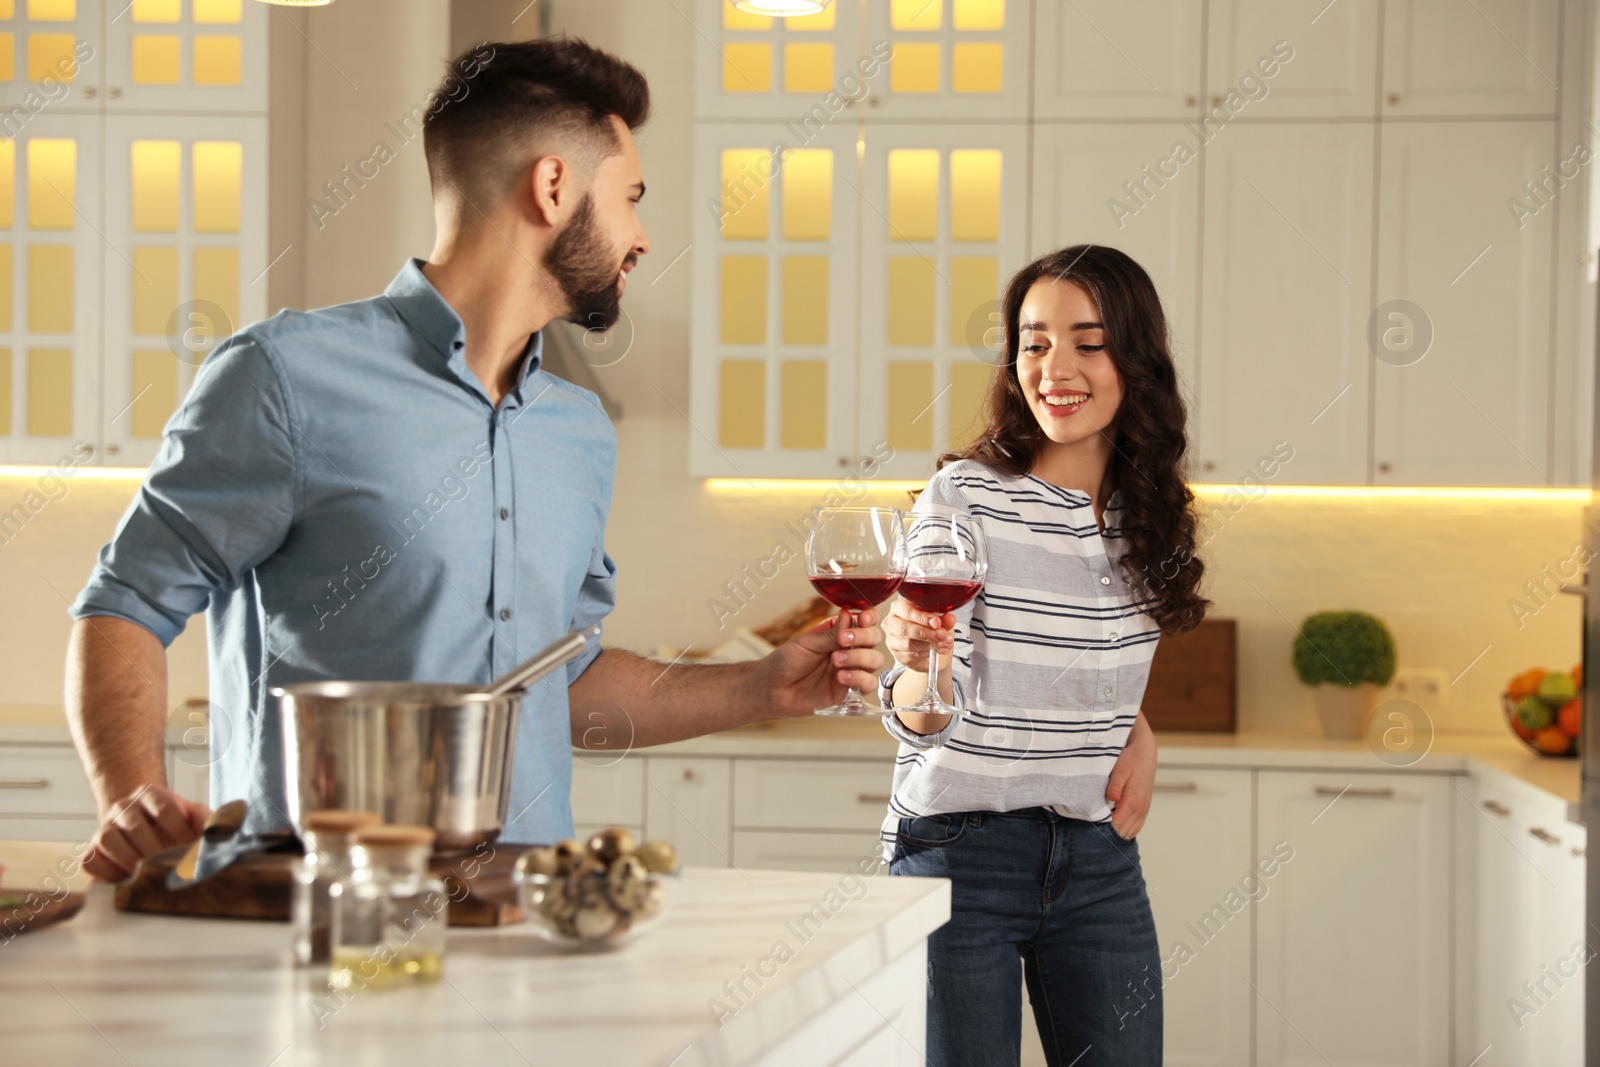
left=112, top=845, right=523, bottom=926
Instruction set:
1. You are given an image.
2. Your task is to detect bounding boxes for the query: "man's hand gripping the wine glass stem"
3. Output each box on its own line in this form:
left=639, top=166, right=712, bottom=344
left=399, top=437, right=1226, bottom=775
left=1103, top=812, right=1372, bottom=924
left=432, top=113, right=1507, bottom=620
left=750, top=611, right=883, bottom=715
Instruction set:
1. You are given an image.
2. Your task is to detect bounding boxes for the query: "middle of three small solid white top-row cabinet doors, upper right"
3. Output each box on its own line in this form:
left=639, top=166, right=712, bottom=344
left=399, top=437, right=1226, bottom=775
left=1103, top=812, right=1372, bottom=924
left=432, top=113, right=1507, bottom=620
left=1206, top=0, right=1379, bottom=122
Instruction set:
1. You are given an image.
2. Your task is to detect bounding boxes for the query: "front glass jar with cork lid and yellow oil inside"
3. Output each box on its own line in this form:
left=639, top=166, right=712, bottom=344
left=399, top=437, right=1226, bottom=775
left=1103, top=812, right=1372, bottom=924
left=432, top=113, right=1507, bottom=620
left=328, top=825, right=450, bottom=990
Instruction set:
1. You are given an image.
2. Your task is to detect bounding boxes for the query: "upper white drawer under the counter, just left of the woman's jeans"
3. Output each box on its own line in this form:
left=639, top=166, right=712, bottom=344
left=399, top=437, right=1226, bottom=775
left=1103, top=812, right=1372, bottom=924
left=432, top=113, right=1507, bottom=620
left=733, top=760, right=894, bottom=830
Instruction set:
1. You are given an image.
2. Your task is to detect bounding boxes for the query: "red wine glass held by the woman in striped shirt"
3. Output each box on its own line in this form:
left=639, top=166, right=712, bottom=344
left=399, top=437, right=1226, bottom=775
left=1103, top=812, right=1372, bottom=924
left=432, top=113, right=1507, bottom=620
left=898, top=504, right=989, bottom=715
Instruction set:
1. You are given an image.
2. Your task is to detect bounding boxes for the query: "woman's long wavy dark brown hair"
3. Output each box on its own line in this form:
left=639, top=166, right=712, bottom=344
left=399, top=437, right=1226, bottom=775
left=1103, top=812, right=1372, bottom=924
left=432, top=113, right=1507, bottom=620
left=939, top=245, right=1211, bottom=632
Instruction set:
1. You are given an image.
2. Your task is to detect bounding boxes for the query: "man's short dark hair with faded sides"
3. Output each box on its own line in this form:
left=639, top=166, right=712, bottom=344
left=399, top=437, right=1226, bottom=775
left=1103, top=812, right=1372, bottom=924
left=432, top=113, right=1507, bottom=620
left=422, top=37, right=650, bottom=211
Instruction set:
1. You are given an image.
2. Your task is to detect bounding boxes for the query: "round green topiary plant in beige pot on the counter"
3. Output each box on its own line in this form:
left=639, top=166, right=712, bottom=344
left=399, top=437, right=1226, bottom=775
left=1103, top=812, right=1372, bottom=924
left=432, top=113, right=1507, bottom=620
left=1294, top=611, right=1395, bottom=739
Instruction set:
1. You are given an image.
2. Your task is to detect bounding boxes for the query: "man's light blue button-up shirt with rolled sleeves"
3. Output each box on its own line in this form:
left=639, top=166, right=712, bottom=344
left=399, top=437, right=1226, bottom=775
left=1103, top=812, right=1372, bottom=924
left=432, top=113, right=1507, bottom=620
left=72, top=259, right=616, bottom=841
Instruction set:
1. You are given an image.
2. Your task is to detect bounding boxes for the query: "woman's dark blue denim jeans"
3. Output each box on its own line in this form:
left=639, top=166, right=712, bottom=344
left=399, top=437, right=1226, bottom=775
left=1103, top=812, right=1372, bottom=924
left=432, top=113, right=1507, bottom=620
left=890, top=808, right=1162, bottom=1067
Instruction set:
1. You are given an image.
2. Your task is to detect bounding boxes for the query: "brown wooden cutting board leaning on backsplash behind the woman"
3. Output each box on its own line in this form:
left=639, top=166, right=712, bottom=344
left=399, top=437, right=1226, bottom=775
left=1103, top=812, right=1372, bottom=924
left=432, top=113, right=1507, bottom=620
left=1141, top=619, right=1238, bottom=733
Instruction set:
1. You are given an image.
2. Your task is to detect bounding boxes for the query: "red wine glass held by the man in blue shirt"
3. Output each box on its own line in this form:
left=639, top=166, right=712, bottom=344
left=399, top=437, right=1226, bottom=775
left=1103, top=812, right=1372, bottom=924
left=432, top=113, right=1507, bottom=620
left=805, top=507, right=906, bottom=715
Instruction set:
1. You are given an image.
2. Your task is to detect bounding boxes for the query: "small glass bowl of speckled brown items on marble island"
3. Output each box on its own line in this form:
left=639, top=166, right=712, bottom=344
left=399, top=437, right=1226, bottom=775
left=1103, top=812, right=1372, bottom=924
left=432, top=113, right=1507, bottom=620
left=512, top=827, right=677, bottom=952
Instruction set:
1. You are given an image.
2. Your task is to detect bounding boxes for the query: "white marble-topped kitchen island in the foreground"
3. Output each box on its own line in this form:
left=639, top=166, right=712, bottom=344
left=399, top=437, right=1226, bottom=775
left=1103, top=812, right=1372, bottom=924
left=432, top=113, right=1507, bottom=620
left=0, top=863, right=950, bottom=1067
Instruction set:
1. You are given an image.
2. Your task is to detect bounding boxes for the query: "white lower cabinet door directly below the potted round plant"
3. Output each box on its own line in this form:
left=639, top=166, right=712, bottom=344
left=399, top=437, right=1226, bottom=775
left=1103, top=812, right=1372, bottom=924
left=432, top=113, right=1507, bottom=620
left=1254, top=771, right=1454, bottom=1067
